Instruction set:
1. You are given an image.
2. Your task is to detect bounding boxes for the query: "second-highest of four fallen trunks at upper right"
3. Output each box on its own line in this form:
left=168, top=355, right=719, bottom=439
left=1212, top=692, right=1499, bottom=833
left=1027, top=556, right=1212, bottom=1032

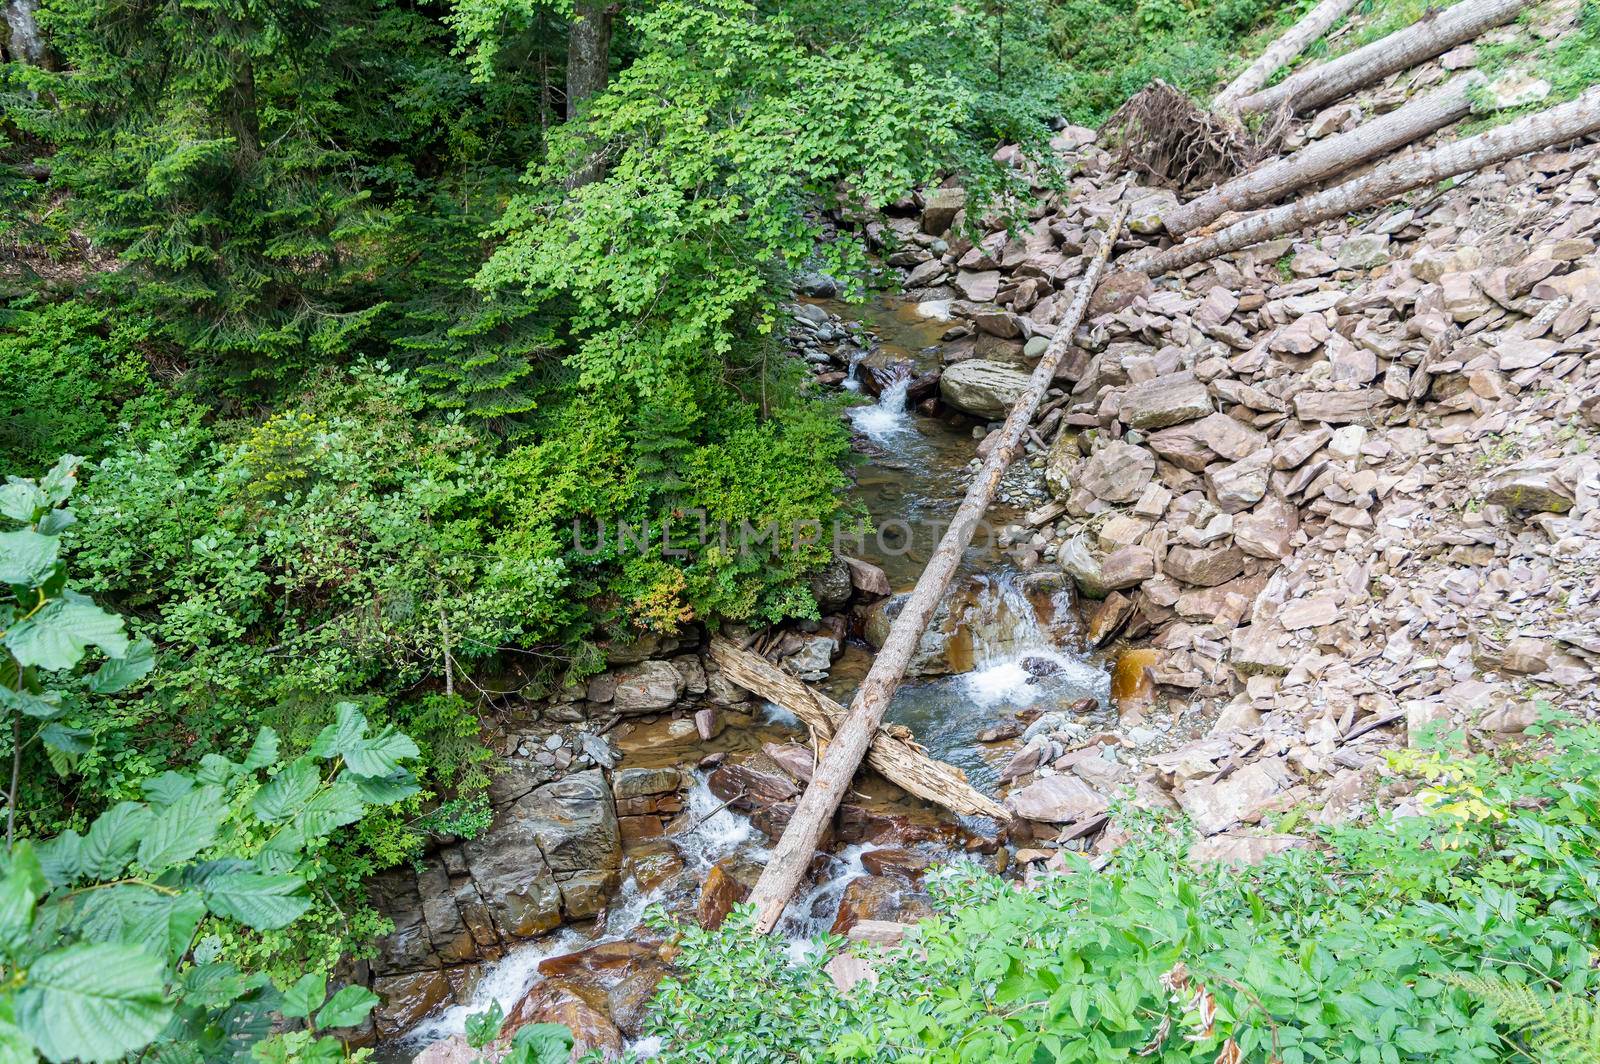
left=1238, top=0, right=1533, bottom=115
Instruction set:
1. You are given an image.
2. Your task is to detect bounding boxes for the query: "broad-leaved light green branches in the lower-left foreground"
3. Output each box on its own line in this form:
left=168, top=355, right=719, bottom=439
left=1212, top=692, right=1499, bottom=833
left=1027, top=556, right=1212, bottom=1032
left=0, top=486, right=418, bottom=1064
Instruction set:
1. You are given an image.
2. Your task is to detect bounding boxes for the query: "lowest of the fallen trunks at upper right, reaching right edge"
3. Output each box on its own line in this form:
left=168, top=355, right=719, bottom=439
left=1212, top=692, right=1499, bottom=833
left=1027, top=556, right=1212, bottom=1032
left=1133, top=88, right=1600, bottom=277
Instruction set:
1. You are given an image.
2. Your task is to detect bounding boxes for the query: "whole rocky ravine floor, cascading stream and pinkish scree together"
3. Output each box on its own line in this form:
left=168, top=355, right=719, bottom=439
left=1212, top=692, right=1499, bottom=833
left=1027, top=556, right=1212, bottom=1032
left=368, top=24, right=1600, bottom=1062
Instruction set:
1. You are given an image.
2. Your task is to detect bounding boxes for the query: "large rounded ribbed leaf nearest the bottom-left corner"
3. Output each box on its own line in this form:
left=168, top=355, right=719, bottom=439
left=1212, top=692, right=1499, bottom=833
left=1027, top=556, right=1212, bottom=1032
left=16, top=942, right=171, bottom=1062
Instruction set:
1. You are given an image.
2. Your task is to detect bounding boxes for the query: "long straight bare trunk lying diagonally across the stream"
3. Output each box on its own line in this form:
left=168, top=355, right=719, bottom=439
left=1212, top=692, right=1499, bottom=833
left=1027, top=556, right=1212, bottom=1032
left=750, top=205, right=1128, bottom=931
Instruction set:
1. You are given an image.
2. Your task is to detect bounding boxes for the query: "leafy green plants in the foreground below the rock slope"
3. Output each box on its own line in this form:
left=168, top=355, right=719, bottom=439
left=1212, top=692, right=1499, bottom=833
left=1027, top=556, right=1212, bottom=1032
left=654, top=725, right=1600, bottom=1064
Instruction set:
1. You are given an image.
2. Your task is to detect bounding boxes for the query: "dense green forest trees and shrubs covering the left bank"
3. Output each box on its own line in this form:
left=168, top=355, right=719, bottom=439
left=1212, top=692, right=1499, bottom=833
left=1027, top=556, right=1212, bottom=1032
left=0, top=0, right=1152, bottom=1061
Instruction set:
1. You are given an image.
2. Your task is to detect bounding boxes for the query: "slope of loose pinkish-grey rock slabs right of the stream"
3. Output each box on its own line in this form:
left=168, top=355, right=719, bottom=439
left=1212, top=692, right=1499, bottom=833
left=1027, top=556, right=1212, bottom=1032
left=874, top=86, right=1600, bottom=858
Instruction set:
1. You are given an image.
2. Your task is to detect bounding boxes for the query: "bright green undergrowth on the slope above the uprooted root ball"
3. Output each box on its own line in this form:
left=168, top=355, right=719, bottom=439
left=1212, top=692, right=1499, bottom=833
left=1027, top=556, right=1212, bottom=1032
left=1050, top=0, right=1309, bottom=126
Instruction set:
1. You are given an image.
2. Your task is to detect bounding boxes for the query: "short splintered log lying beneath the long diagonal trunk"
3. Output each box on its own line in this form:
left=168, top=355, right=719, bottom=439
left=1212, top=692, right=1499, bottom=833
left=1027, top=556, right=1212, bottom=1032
left=710, top=637, right=1011, bottom=822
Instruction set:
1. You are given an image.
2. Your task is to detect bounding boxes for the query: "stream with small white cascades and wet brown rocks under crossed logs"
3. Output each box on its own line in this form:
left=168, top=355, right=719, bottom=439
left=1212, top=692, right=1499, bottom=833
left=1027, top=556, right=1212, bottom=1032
left=371, top=288, right=1115, bottom=1059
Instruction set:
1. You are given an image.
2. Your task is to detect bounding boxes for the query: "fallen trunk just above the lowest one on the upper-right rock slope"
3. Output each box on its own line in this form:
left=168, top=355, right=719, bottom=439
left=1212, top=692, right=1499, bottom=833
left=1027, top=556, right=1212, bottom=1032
left=1162, top=75, right=1483, bottom=237
